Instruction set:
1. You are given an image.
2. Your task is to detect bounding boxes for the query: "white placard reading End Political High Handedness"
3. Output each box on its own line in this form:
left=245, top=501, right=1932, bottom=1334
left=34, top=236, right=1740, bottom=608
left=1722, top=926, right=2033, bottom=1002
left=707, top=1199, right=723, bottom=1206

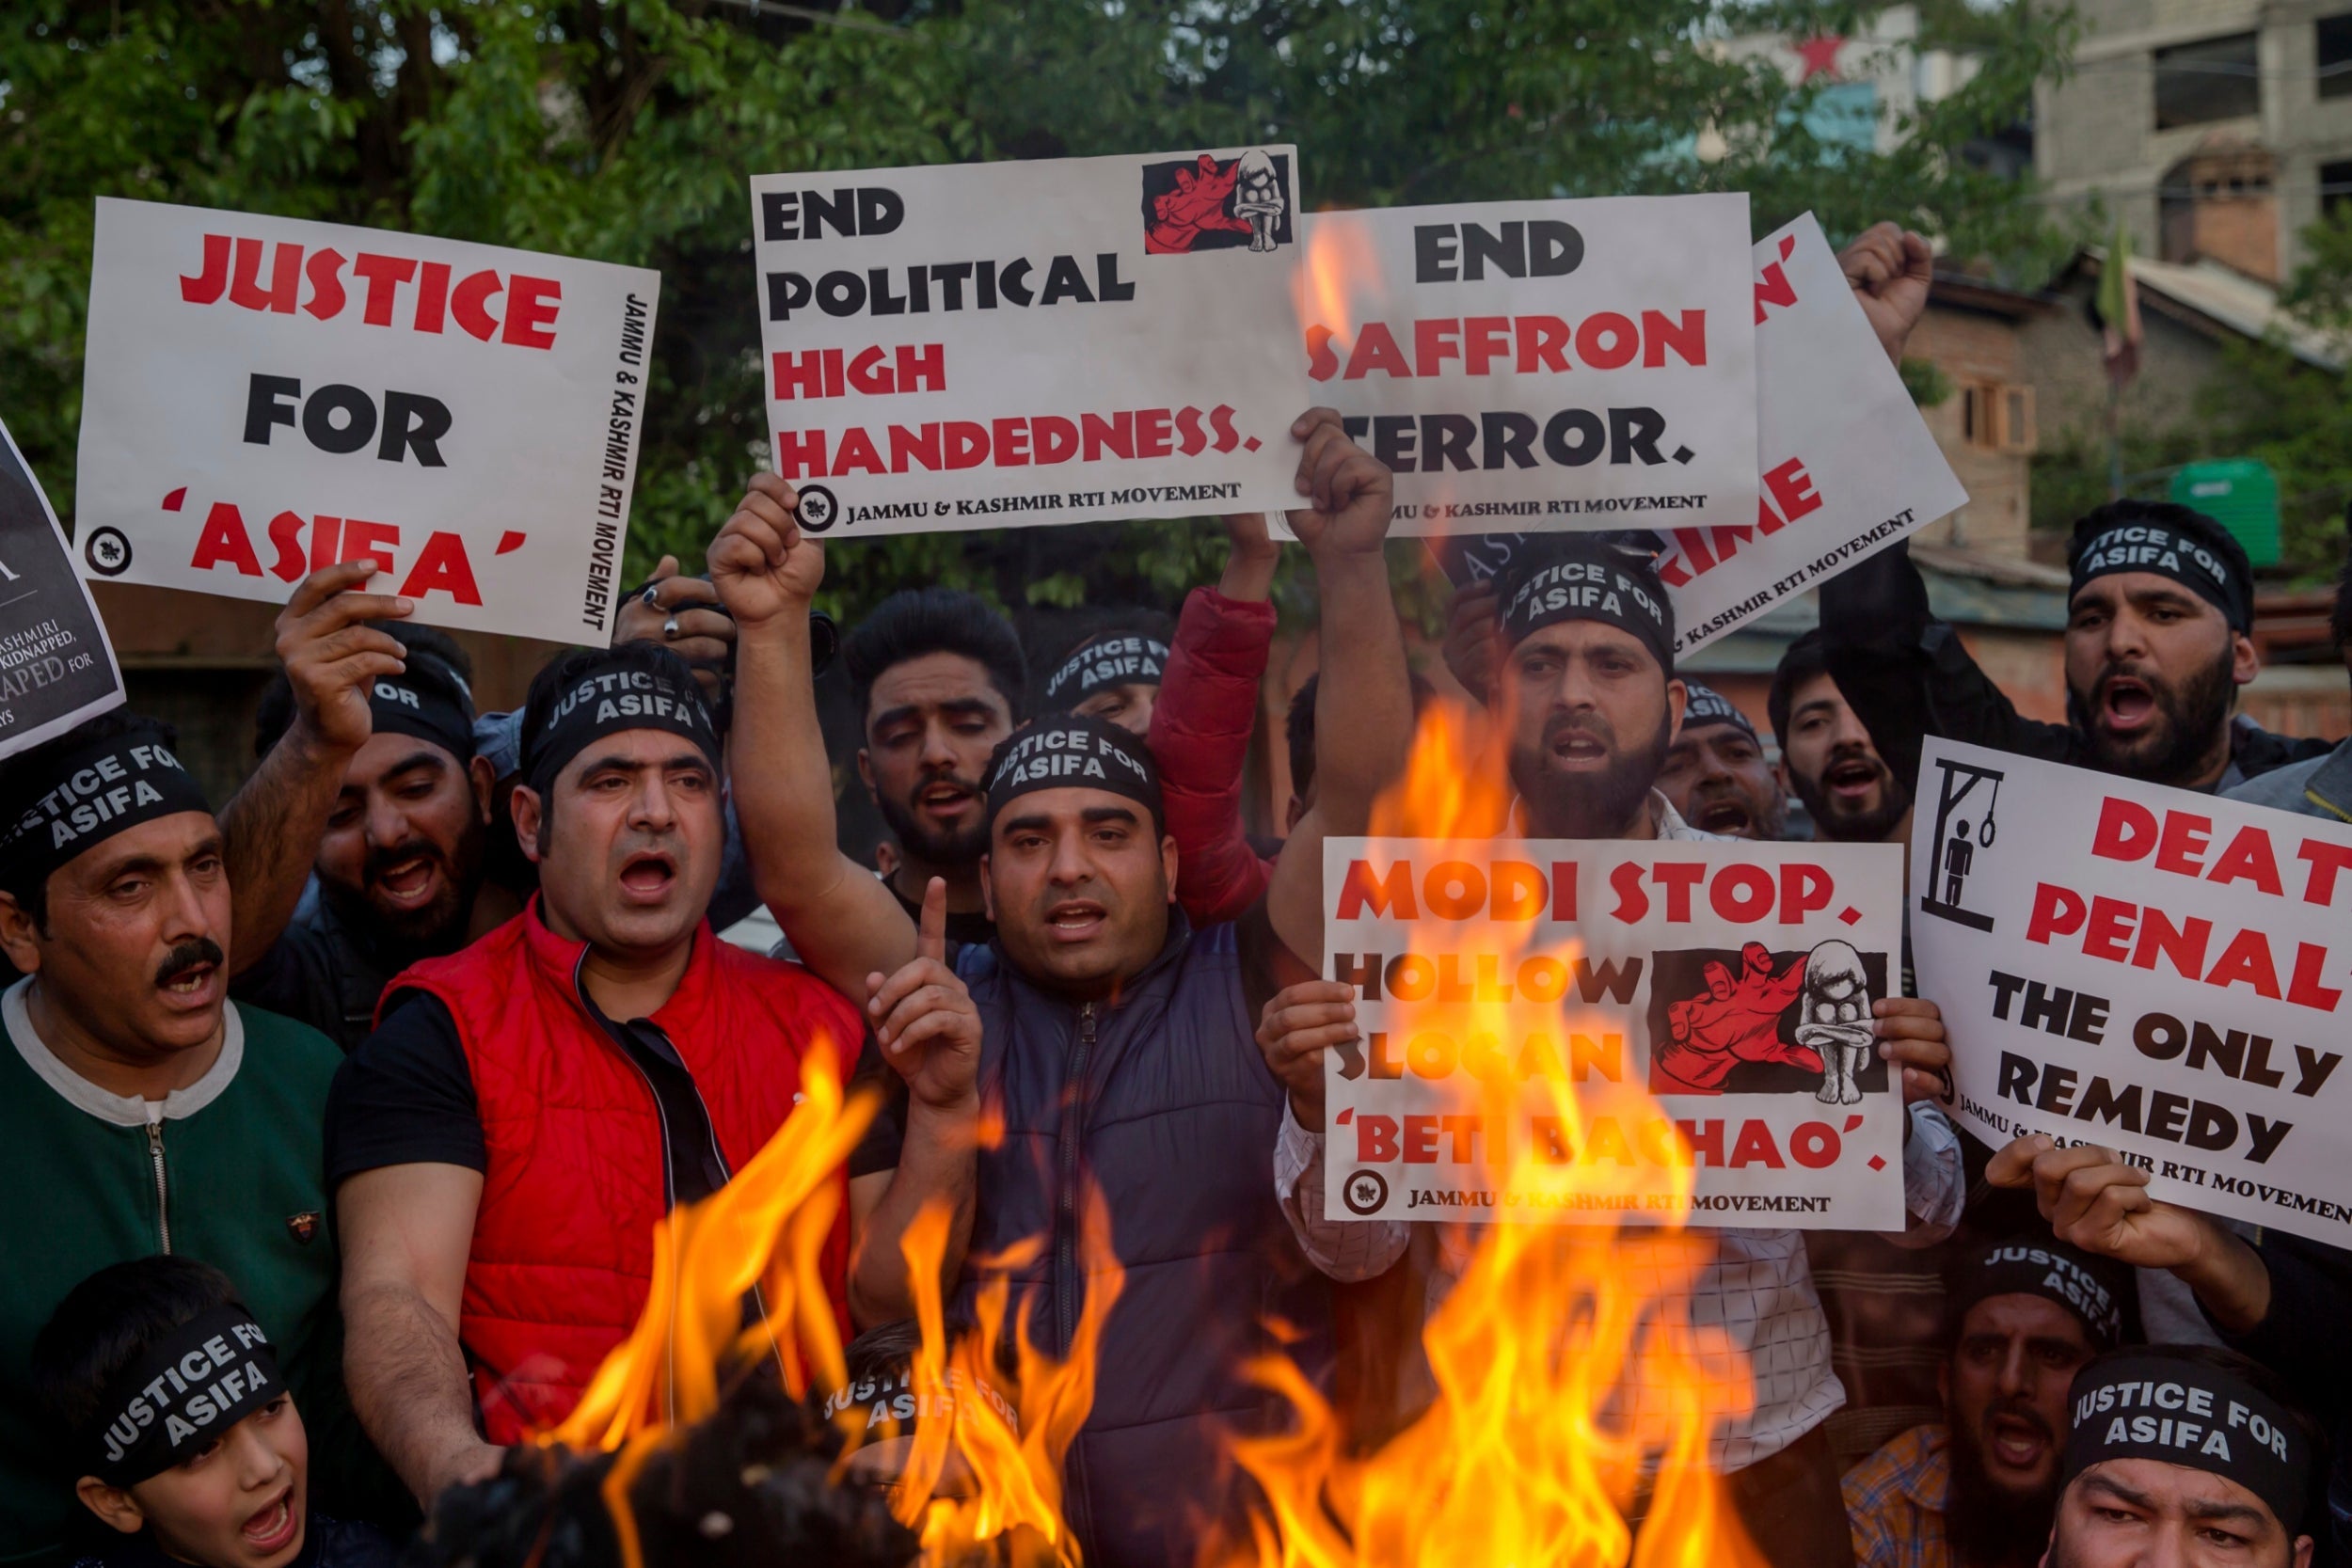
left=751, top=143, right=1308, bottom=538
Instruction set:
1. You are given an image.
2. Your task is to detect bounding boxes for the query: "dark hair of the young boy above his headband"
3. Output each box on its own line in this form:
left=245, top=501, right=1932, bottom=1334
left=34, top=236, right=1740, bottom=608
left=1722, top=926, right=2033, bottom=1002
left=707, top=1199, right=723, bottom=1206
left=31, top=1253, right=243, bottom=1465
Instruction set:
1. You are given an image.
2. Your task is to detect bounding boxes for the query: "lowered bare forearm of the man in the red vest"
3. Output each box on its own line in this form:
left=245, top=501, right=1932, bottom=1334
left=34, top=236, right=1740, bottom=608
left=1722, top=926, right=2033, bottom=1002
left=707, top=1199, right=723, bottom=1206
left=334, top=1164, right=503, bottom=1514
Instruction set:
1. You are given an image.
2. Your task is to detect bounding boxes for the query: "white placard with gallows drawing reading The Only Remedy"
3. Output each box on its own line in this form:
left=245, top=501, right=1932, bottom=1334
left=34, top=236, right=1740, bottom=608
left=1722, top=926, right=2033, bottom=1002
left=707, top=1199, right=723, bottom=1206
left=1910, top=740, right=2352, bottom=1246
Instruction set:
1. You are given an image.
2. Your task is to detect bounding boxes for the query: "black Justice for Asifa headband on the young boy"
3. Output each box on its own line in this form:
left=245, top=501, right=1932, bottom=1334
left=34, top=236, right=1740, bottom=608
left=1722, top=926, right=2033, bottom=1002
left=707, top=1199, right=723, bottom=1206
left=83, top=1303, right=287, bottom=1486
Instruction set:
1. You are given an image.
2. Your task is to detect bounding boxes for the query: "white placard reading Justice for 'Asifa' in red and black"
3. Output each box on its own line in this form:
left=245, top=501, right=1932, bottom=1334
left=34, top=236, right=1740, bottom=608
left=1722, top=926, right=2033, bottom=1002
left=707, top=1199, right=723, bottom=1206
left=75, top=198, right=661, bottom=644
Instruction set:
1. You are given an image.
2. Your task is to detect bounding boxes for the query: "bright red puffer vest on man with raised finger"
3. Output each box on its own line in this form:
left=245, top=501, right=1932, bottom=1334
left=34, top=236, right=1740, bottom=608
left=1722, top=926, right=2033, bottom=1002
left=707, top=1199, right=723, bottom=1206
left=384, top=898, right=866, bottom=1444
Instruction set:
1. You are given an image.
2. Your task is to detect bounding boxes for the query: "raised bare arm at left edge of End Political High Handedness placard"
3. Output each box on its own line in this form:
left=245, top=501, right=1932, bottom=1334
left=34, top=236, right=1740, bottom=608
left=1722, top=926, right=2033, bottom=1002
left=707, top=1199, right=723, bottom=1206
left=710, top=472, right=915, bottom=997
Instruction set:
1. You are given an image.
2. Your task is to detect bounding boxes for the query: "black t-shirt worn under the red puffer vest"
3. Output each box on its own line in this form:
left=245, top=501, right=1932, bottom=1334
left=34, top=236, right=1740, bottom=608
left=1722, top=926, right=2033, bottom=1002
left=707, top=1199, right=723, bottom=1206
left=327, top=992, right=727, bottom=1204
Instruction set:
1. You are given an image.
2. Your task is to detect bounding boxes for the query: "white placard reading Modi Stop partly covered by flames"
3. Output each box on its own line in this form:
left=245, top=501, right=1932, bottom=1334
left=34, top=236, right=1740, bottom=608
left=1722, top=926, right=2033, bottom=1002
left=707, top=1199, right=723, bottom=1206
left=1325, top=839, right=1903, bottom=1229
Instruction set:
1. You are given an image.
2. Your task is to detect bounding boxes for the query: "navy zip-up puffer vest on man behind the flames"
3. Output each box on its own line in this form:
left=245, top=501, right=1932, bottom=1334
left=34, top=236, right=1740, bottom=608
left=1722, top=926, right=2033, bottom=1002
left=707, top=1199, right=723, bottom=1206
left=958, top=910, right=1331, bottom=1568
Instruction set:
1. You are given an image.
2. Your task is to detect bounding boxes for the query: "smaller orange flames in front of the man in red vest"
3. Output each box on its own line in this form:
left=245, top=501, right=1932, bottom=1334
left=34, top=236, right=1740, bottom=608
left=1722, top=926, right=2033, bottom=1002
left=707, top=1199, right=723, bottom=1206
left=541, top=1051, right=1124, bottom=1568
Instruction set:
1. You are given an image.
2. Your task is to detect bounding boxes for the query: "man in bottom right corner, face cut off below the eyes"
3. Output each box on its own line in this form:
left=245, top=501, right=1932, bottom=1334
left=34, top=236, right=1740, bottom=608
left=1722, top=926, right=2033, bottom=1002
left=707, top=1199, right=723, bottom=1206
left=2044, top=1345, right=2324, bottom=1568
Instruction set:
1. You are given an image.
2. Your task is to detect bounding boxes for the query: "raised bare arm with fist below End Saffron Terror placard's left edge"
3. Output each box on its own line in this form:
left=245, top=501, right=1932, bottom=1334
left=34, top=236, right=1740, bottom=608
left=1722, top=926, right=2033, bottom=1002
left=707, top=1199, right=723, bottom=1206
left=1265, top=409, right=1414, bottom=974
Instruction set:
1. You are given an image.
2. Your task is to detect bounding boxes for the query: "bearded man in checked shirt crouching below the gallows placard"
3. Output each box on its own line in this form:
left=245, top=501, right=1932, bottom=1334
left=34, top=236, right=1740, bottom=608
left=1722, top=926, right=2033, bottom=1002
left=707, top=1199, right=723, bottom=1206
left=1844, top=1234, right=2131, bottom=1568
